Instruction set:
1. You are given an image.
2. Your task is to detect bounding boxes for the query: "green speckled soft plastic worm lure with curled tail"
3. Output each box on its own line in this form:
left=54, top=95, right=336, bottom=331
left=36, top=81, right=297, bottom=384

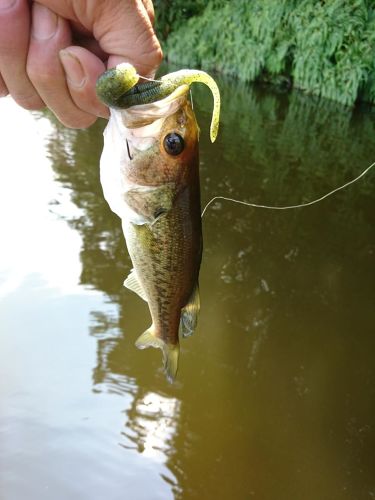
left=96, top=63, right=220, bottom=142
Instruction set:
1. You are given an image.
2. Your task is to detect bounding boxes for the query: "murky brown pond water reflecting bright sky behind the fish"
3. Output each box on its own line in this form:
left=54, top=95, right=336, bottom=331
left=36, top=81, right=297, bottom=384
left=0, top=75, right=375, bottom=500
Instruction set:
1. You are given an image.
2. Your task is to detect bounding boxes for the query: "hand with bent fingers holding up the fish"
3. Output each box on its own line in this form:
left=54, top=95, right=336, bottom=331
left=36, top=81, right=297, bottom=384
left=0, top=0, right=162, bottom=128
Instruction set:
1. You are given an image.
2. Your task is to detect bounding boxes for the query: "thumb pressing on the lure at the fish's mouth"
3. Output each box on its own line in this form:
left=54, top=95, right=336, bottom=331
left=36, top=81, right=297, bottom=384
left=93, top=0, right=163, bottom=77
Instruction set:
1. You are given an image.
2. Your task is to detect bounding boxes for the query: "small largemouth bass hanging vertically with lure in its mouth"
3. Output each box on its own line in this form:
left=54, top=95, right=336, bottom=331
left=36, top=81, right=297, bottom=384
left=99, top=64, right=220, bottom=381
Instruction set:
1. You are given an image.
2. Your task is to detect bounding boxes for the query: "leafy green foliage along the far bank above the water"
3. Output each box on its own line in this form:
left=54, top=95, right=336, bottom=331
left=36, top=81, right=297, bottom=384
left=155, top=0, right=375, bottom=105
